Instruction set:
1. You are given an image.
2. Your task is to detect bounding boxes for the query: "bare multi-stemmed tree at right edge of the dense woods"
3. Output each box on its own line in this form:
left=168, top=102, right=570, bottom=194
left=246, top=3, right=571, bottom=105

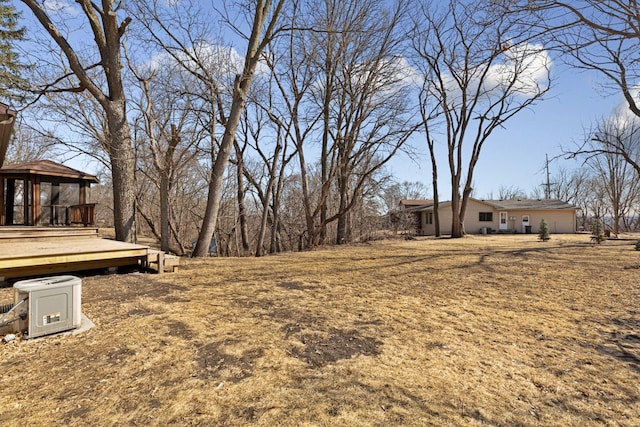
left=313, top=1, right=417, bottom=244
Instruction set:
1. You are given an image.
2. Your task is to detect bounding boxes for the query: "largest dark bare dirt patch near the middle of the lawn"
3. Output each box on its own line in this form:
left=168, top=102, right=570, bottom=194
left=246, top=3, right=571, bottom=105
left=291, top=329, right=382, bottom=368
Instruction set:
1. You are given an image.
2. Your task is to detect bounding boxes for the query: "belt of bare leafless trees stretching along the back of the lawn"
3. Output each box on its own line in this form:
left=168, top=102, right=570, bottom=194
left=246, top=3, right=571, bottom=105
left=0, top=0, right=640, bottom=256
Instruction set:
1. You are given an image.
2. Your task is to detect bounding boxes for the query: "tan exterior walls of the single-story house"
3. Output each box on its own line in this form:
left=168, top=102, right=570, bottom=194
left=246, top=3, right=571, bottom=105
left=420, top=200, right=576, bottom=236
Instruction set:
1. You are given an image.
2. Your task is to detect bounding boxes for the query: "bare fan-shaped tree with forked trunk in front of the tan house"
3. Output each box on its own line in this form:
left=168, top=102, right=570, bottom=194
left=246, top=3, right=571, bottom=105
left=413, top=0, right=551, bottom=237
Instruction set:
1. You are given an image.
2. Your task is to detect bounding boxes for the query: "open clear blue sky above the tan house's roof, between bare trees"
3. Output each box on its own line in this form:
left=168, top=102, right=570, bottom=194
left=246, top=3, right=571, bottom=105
left=390, top=60, right=623, bottom=200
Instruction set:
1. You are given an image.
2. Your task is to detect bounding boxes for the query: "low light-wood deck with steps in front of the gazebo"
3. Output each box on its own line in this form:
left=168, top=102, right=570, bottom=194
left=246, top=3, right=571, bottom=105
left=0, top=227, right=175, bottom=280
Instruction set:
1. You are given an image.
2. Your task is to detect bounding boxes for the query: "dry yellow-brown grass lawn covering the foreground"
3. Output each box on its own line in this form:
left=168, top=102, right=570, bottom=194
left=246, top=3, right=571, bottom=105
left=0, top=235, right=640, bottom=426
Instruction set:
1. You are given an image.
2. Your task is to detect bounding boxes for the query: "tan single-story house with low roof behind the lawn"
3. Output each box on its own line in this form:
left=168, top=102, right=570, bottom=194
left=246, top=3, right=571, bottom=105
left=401, top=198, right=578, bottom=236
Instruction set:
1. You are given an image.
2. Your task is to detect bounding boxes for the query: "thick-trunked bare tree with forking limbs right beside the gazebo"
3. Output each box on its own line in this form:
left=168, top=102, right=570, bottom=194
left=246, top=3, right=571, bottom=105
left=22, top=0, right=135, bottom=241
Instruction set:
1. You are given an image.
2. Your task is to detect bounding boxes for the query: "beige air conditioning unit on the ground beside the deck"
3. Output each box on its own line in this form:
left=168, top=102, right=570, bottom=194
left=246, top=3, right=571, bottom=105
left=13, top=276, right=82, bottom=338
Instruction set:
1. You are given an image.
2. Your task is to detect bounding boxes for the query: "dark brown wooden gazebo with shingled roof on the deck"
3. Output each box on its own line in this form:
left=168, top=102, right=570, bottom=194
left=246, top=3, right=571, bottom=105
left=0, top=160, right=99, bottom=226
